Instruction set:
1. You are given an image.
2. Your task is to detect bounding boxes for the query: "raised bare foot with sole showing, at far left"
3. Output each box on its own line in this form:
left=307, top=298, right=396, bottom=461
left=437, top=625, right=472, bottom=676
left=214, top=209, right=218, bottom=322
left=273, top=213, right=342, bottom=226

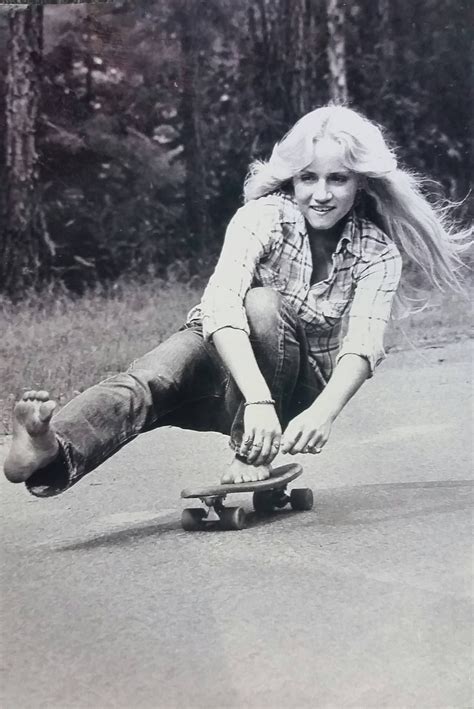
left=3, top=391, right=59, bottom=483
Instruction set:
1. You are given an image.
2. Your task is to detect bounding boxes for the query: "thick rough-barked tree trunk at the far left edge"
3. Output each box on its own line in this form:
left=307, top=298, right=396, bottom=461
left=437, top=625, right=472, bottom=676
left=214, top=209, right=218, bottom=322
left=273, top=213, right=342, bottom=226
left=0, top=7, right=52, bottom=295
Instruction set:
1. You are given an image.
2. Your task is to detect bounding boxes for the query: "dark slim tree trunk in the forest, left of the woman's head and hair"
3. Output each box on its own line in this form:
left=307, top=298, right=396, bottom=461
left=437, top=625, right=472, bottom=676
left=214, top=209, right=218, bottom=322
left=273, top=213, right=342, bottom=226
left=177, top=0, right=211, bottom=251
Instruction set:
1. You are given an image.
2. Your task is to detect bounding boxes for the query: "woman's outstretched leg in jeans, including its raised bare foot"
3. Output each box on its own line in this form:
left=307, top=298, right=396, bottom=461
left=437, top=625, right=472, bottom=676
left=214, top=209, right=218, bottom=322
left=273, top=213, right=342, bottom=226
left=5, top=327, right=228, bottom=495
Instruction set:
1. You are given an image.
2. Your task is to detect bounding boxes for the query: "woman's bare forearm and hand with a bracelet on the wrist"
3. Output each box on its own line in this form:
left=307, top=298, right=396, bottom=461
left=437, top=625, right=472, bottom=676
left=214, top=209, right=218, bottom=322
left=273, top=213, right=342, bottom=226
left=212, top=327, right=281, bottom=465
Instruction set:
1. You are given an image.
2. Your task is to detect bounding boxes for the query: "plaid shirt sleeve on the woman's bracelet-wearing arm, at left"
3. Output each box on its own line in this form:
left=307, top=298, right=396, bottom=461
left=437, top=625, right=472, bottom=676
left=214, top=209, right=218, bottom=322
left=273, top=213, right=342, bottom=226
left=200, top=200, right=281, bottom=338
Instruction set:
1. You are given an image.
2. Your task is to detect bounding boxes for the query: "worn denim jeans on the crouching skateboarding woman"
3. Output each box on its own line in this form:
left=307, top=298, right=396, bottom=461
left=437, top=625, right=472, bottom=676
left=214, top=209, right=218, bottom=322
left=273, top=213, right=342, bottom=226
left=27, top=288, right=323, bottom=496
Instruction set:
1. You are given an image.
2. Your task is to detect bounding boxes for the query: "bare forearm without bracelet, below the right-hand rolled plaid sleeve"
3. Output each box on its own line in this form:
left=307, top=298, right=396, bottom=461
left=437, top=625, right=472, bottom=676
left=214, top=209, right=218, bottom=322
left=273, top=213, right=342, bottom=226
left=312, top=354, right=369, bottom=420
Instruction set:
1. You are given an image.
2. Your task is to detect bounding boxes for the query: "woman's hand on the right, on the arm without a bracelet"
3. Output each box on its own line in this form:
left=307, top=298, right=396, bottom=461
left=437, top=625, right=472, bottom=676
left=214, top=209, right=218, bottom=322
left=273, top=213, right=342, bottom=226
left=281, top=403, right=334, bottom=455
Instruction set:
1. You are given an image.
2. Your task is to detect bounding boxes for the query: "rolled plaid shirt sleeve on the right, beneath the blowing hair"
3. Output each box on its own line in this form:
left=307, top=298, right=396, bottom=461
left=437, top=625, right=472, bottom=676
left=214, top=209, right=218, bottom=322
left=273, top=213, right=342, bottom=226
left=336, top=244, right=402, bottom=377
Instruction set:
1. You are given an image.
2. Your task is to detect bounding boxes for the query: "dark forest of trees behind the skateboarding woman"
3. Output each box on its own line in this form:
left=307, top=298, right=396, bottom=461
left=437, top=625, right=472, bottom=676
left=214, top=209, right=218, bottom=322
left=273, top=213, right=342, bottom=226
left=0, top=0, right=473, bottom=298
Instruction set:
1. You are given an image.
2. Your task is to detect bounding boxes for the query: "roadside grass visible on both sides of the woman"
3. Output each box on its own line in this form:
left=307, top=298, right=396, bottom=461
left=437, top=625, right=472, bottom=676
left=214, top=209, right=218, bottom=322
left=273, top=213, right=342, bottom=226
left=0, top=280, right=471, bottom=434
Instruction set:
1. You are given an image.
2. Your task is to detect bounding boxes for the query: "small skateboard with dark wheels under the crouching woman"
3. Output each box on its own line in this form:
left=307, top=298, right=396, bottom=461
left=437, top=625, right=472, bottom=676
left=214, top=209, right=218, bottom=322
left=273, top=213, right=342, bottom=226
left=181, top=463, right=313, bottom=532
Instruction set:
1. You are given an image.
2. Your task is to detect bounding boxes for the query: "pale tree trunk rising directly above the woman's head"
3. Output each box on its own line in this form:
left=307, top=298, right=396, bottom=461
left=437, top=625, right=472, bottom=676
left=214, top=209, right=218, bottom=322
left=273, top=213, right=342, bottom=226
left=327, top=0, right=348, bottom=104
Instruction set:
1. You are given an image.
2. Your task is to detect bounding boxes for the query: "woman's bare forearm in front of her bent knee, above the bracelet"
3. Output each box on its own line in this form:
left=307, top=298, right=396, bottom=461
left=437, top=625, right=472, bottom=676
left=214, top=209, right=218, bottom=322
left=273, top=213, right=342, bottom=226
left=212, top=327, right=272, bottom=401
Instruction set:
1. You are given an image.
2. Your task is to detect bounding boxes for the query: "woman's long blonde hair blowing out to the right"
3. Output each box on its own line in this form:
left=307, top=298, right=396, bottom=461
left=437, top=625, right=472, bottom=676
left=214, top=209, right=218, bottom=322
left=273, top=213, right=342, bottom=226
left=244, top=106, right=472, bottom=305
